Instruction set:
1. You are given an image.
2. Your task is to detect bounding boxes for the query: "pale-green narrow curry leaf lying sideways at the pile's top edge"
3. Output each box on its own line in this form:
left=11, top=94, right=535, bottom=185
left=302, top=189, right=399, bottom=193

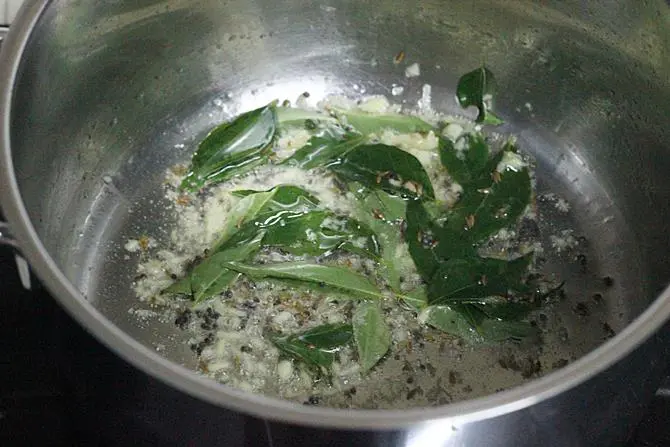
left=334, top=109, right=433, bottom=136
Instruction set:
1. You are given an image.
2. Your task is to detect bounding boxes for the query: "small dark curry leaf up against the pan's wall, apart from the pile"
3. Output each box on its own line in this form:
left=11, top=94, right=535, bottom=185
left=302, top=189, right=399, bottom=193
left=456, top=66, right=501, bottom=124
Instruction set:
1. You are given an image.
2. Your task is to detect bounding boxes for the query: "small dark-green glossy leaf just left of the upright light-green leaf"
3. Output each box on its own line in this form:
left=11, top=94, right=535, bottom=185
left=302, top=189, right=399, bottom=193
left=271, top=324, right=353, bottom=368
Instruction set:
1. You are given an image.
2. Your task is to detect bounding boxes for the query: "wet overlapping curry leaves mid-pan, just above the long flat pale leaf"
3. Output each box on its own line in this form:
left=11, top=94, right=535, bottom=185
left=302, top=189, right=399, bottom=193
left=176, top=185, right=379, bottom=303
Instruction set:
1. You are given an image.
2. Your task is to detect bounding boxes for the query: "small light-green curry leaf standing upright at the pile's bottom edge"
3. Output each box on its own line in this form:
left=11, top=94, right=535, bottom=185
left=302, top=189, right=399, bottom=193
left=352, top=301, right=391, bottom=372
